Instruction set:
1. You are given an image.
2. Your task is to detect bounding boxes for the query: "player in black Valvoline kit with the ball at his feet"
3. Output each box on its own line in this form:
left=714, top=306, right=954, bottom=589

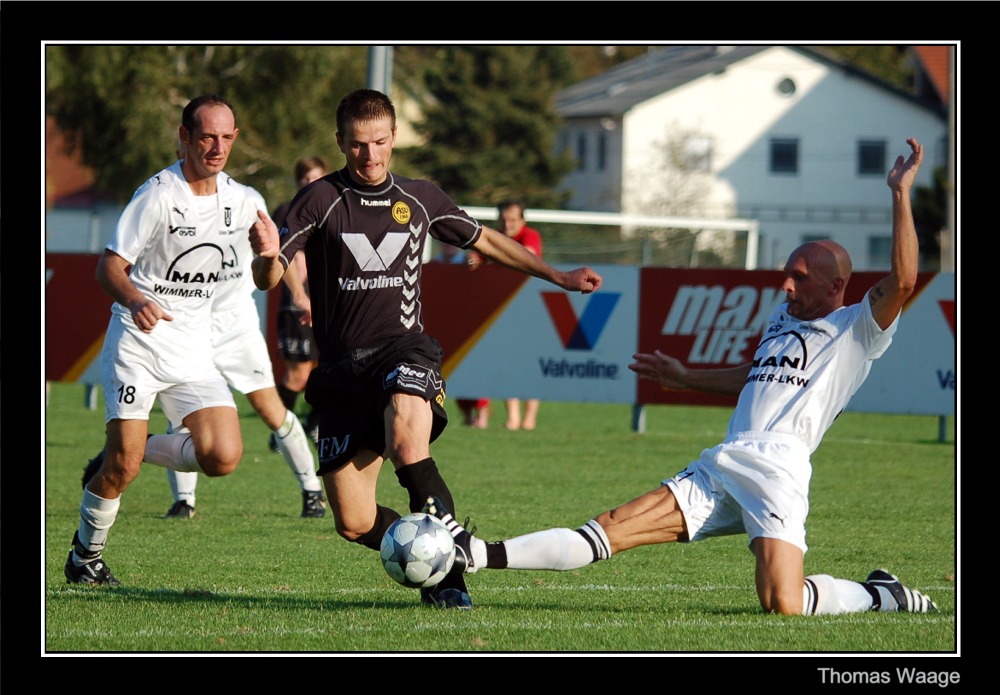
left=250, top=89, right=601, bottom=608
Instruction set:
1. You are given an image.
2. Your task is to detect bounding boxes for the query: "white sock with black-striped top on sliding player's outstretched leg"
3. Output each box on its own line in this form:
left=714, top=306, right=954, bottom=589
left=504, top=521, right=611, bottom=570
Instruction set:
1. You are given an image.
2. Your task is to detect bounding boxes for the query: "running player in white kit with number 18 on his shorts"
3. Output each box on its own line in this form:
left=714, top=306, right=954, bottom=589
left=64, top=95, right=278, bottom=586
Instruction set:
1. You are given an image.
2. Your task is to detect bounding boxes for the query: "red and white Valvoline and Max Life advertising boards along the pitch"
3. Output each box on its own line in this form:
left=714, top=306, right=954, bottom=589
left=43, top=253, right=957, bottom=415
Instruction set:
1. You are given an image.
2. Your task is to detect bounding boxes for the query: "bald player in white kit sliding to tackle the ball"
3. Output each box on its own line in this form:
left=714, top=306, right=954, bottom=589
left=424, top=138, right=937, bottom=615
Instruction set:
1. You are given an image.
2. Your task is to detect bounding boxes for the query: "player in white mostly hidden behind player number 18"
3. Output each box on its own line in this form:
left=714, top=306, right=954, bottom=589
left=156, top=148, right=326, bottom=519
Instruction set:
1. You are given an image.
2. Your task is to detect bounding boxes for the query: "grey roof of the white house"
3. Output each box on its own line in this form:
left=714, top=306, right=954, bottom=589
left=556, top=45, right=940, bottom=118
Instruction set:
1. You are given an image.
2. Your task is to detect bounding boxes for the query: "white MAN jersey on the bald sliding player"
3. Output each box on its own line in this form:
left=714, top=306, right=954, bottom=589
left=728, top=294, right=899, bottom=453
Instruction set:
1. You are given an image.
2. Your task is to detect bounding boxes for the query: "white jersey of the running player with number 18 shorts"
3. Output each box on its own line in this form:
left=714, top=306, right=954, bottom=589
left=107, top=162, right=263, bottom=374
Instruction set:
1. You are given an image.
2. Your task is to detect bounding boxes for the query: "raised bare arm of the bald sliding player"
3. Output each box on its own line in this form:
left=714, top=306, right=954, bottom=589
left=868, top=138, right=924, bottom=330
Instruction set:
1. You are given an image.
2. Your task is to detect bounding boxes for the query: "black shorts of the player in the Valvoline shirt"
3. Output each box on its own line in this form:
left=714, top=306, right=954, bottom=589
left=306, top=333, right=448, bottom=475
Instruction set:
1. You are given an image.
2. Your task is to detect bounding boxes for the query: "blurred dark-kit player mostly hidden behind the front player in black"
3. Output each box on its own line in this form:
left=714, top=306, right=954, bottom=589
left=268, top=156, right=327, bottom=452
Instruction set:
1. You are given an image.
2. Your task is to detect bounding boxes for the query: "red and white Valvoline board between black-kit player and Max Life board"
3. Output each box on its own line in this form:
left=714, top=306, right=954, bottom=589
left=423, top=263, right=639, bottom=403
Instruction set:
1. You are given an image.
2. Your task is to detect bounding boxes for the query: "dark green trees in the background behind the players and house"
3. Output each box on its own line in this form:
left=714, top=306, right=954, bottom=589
left=45, top=45, right=912, bottom=218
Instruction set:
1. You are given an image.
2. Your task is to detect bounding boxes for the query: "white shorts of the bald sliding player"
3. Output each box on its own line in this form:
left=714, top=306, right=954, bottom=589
left=663, top=432, right=812, bottom=553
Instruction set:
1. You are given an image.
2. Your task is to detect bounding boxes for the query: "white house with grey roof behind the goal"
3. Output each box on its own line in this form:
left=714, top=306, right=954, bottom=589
left=556, top=46, right=950, bottom=270
